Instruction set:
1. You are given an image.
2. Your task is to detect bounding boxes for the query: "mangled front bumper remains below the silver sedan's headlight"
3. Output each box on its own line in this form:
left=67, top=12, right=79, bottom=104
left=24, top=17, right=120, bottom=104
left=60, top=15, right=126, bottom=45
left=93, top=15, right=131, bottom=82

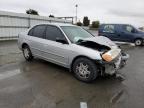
left=97, top=53, right=129, bottom=75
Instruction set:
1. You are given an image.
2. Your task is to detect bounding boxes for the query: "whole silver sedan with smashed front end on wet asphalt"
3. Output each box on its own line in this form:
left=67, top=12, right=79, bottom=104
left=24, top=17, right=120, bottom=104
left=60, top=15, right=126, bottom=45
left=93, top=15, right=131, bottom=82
left=18, top=24, right=128, bottom=82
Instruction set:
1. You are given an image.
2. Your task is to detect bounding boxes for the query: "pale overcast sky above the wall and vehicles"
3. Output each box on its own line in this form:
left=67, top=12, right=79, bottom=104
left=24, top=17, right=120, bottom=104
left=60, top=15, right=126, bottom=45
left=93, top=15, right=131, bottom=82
left=0, top=0, right=144, bottom=26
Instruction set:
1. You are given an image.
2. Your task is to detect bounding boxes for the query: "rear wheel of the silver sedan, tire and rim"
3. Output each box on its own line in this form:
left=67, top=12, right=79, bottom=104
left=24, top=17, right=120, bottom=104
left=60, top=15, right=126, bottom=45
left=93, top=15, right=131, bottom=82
left=22, top=45, right=33, bottom=61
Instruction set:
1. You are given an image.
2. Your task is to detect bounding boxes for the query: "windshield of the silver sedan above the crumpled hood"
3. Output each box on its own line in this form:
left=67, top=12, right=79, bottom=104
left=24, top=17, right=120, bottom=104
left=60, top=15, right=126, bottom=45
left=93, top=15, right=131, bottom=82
left=61, top=26, right=93, bottom=43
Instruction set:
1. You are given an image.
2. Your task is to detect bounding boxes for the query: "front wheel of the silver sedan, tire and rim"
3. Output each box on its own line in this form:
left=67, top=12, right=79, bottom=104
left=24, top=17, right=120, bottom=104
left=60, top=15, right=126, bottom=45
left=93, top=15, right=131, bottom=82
left=72, top=57, right=98, bottom=83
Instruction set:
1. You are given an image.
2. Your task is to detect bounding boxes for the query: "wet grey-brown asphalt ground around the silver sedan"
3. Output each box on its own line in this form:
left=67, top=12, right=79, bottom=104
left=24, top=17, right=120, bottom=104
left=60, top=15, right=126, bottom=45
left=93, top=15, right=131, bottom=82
left=0, top=41, right=144, bottom=108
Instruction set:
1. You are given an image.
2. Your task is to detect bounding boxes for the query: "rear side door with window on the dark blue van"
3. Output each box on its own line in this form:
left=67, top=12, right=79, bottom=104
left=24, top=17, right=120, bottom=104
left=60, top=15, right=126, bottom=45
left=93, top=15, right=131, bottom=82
left=101, top=24, right=118, bottom=41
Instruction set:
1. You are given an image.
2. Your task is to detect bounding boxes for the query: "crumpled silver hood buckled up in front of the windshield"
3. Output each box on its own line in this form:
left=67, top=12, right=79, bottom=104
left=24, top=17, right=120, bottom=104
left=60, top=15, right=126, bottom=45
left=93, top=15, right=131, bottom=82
left=84, top=36, right=117, bottom=48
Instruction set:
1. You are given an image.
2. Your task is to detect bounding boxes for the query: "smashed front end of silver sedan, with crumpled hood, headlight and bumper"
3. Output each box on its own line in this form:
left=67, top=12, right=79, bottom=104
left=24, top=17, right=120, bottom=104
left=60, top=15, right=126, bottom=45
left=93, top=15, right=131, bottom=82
left=78, top=38, right=129, bottom=75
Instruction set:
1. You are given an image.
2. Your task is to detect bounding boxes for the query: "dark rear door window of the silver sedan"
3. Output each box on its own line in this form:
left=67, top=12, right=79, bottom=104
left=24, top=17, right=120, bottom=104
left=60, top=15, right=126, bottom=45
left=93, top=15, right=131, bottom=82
left=29, top=25, right=46, bottom=38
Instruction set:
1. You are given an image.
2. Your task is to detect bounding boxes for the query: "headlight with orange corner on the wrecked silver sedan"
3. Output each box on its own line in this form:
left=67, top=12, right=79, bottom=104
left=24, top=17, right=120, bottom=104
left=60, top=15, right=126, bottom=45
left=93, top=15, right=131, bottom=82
left=102, top=49, right=121, bottom=62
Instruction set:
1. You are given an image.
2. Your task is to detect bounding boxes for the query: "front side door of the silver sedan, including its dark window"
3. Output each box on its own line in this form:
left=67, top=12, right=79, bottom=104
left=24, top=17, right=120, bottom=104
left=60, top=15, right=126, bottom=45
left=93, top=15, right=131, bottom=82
left=43, top=25, right=70, bottom=67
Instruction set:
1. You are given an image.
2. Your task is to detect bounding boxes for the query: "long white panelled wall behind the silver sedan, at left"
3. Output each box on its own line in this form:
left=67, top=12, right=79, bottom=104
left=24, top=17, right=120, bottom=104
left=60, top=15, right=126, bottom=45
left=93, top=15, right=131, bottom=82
left=0, top=11, right=72, bottom=40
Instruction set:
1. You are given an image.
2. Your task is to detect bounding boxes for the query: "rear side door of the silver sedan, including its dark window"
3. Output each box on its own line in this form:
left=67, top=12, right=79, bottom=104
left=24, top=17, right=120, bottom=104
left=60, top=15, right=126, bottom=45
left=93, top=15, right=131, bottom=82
left=28, top=25, right=46, bottom=56
